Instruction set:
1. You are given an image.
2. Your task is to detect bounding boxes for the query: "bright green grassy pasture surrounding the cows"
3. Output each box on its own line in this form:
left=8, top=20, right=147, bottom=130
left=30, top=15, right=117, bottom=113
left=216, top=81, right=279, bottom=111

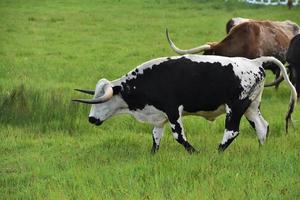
left=0, top=0, right=300, bottom=199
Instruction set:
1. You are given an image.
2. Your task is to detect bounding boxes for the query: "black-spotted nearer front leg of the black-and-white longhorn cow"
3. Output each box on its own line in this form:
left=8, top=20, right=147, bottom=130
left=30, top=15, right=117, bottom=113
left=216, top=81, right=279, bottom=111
left=168, top=106, right=196, bottom=153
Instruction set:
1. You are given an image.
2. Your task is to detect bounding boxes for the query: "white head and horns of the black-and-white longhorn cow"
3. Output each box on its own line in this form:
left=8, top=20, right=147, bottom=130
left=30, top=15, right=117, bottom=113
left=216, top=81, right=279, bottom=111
left=73, top=79, right=126, bottom=125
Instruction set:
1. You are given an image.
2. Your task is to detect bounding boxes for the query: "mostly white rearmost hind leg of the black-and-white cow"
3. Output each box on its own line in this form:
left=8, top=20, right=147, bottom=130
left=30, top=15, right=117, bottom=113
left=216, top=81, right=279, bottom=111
left=245, top=94, right=269, bottom=144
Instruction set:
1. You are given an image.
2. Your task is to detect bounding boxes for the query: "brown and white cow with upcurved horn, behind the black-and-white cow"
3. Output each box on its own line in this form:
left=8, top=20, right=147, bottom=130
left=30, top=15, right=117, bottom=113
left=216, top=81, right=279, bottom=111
left=166, top=18, right=300, bottom=86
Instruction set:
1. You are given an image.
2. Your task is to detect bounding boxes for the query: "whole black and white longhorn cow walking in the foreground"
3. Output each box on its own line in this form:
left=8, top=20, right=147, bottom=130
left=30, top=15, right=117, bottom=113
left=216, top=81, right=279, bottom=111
left=74, top=55, right=297, bottom=153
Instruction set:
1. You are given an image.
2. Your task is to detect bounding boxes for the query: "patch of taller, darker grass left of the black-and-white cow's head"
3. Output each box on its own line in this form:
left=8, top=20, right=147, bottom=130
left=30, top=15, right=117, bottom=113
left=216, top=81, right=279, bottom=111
left=0, top=85, right=88, bottom=134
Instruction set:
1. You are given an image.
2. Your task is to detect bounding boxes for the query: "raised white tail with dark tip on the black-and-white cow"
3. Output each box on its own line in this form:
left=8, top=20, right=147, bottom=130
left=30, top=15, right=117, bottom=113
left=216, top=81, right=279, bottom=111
left=255, top=57, right=297, bottom=133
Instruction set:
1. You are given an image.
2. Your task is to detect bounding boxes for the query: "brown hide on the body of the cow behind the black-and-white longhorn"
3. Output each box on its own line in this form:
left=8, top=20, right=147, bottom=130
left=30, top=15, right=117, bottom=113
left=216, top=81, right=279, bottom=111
left=204, top=20, right=299, bottom=62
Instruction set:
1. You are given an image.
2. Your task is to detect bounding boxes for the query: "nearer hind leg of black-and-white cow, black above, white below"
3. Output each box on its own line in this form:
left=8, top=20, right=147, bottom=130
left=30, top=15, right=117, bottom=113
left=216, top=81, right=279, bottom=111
left=219, top=100, right=251, bottom=152
